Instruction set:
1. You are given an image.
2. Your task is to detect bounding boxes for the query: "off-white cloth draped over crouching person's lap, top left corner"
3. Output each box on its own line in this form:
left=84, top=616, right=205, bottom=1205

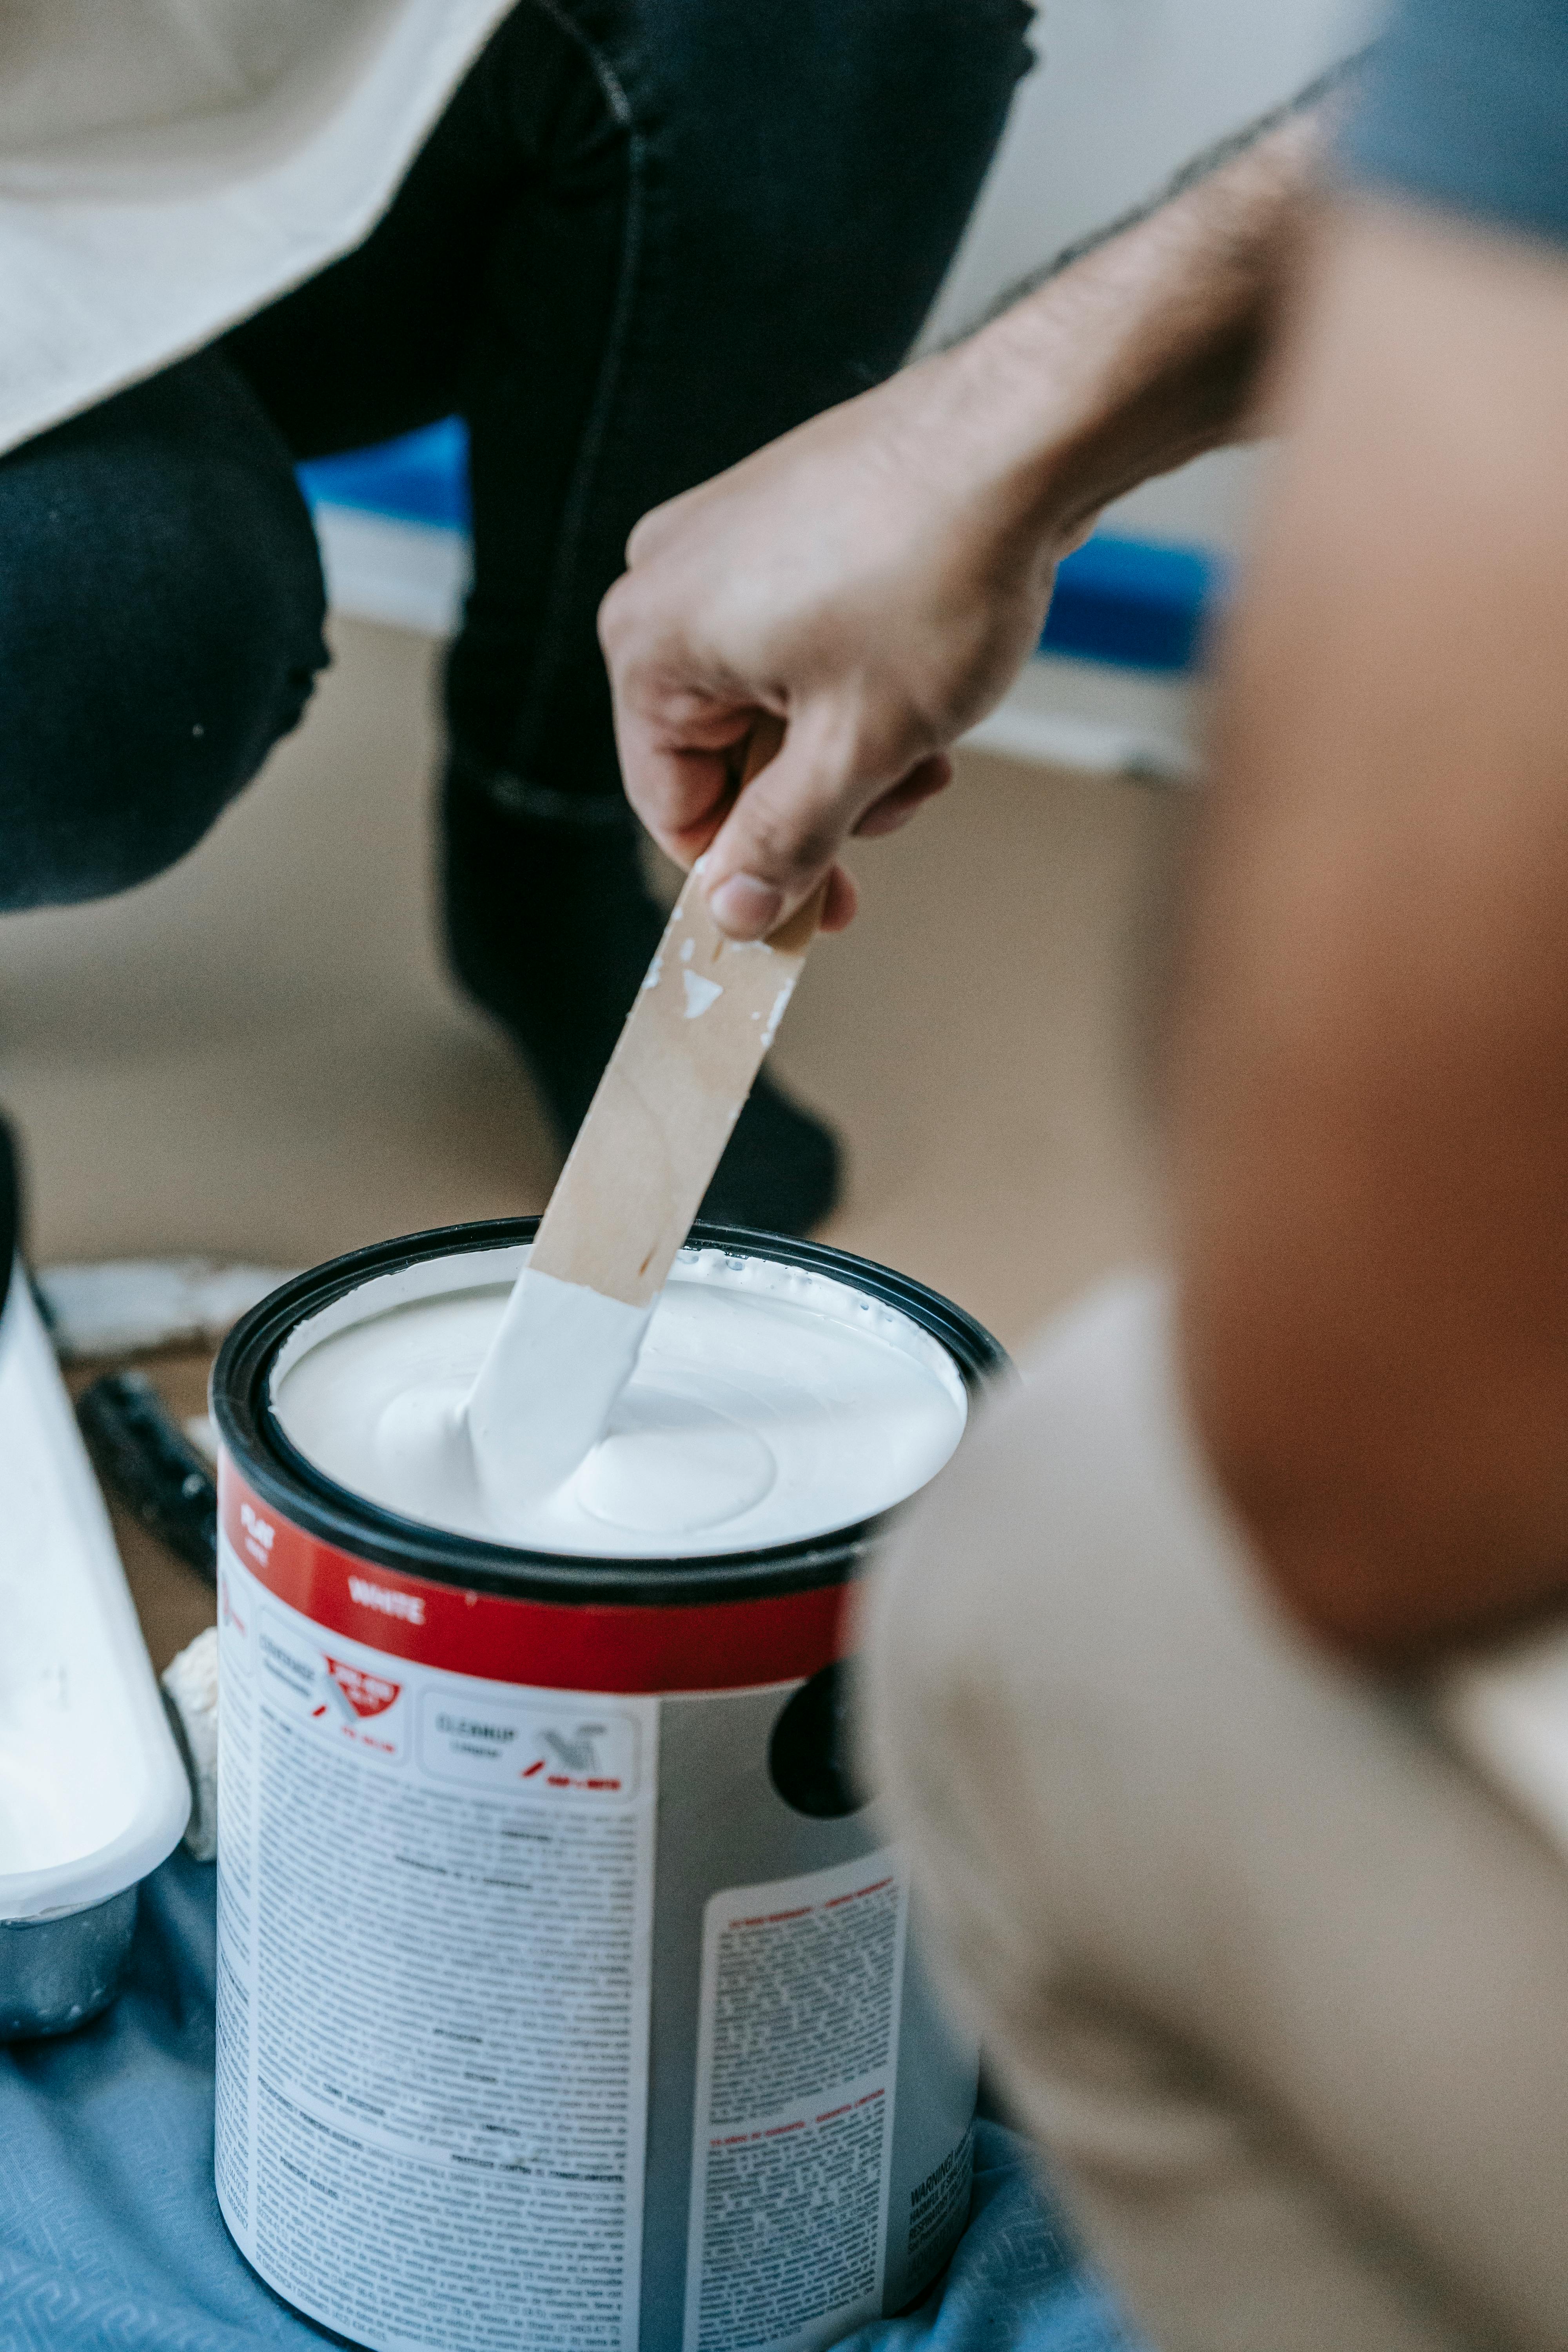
left=0, top=0, right=510, bottom=449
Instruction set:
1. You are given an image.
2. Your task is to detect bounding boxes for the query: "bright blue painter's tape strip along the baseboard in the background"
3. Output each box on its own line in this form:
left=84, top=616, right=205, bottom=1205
left=299, top=416, right=1227, bottom=670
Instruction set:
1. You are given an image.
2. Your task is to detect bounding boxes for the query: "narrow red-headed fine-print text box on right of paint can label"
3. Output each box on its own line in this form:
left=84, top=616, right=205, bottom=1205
left=684, top=1846, right=910, bottom=2352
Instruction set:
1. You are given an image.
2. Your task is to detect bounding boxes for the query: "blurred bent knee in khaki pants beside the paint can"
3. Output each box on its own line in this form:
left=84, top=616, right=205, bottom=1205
left=870, top=1279, right=1568, bottom=2352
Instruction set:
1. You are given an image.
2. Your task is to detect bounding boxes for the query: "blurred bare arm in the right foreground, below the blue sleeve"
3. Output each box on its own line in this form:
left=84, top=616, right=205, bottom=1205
left=1173, top=205, right=1568, bottom=1656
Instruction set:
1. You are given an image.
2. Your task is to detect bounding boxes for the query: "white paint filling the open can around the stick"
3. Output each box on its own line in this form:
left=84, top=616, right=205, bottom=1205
left=273, top=1249, right=966, bottom=1557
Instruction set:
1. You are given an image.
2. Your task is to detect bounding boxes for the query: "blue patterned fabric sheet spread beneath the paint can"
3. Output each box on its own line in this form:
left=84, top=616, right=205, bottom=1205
left=0, top=1851, right=1136, bottom=2352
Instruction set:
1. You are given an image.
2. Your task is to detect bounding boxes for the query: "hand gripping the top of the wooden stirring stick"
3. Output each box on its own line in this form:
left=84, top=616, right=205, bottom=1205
left=599, top=336, right=1086, bottom=938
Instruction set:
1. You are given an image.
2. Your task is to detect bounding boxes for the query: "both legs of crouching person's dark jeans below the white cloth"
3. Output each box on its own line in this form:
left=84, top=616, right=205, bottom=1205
left=0, top=0, right=1030, bottom=1195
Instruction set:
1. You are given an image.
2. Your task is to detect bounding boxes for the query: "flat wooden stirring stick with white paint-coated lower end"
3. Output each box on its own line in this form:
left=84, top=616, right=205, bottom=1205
left=465, top=720, right=823, bottom=1524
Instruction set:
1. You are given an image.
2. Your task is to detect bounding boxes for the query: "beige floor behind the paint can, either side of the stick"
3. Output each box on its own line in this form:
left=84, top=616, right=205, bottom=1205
left=0, top=623, right=1182, bottom=1341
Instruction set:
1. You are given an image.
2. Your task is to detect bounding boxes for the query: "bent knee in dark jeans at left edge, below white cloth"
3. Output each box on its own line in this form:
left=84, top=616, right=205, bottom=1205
left=0, top=355, right=327, bottom=908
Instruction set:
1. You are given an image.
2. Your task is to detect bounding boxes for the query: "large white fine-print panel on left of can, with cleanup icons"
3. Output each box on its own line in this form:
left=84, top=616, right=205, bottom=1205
left=216, top=1543, right=658, bottom=2352
